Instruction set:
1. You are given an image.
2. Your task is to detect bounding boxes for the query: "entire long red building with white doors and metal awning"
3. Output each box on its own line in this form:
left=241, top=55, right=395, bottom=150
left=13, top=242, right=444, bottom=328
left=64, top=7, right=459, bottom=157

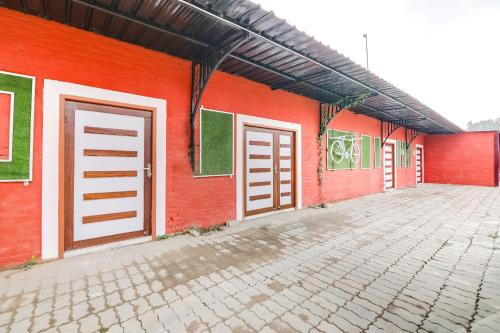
left=0, top=0, right=498, bottom=266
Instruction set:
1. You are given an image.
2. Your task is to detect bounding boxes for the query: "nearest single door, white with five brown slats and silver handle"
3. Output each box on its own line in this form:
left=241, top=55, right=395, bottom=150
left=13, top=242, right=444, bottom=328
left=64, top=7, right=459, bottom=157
left=64, top=101, right=152, bottom=250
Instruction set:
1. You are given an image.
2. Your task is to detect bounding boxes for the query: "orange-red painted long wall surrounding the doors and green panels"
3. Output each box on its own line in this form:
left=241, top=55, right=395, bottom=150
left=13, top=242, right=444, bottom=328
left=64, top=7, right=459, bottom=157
left=0, top=8, right=422, bottom=266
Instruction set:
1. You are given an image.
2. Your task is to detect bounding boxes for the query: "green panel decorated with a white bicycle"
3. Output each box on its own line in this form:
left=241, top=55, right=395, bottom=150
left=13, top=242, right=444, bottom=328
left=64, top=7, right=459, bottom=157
left=326, top=129, right=360, bottom=170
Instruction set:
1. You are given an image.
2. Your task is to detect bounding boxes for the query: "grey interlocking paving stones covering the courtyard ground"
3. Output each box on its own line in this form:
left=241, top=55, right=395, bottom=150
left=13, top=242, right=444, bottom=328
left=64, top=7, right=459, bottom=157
left=0, top=185, right=500, bottom=332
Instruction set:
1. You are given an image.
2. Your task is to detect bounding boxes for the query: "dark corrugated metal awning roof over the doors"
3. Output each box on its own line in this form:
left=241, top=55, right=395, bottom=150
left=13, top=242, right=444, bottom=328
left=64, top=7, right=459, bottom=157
left=4, top=0, right=462, bottom=133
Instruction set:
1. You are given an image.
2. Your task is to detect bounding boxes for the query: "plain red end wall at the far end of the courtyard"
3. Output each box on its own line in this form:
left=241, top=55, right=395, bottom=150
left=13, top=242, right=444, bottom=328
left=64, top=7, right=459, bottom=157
left=424, top=132, right=498, bottom=186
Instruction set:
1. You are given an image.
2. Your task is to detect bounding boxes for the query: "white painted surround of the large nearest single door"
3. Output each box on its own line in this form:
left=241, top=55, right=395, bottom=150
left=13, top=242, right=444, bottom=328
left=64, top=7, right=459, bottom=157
left=42, top=80, right=167, bottom=259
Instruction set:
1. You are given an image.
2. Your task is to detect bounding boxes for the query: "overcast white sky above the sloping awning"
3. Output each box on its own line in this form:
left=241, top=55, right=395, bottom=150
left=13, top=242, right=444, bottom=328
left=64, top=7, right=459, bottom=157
left=253, top=0, right=500, bottom=128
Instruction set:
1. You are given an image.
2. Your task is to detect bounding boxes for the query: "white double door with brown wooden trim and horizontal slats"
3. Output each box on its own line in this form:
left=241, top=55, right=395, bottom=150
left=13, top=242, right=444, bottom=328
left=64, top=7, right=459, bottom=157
left=244, top=126, right=295, bottom=216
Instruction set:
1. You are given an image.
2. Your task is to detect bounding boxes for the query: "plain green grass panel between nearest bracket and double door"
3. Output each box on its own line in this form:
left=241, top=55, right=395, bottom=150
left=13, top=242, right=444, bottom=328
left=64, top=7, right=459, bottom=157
left=200, top=109, right=234, bottom=176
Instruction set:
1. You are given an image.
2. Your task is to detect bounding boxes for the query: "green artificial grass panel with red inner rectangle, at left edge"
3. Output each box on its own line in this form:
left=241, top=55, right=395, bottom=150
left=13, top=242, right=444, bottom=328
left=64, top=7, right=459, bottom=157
left=0, top=73, right=34, bottom=181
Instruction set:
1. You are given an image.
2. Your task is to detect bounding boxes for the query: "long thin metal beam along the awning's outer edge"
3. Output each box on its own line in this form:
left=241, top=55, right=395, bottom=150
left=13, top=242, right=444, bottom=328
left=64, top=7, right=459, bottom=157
left=176, top=0, right=456, bottom=133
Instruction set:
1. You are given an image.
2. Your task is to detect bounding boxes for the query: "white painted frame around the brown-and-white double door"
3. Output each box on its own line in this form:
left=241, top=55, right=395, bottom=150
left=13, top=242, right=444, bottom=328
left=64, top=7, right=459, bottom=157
left=236, top=114, right=302, bottom=221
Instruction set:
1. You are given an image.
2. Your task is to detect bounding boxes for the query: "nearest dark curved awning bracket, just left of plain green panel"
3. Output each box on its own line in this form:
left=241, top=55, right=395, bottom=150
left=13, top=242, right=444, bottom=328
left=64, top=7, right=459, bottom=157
left=189, top=31, right=250, bottom=172
